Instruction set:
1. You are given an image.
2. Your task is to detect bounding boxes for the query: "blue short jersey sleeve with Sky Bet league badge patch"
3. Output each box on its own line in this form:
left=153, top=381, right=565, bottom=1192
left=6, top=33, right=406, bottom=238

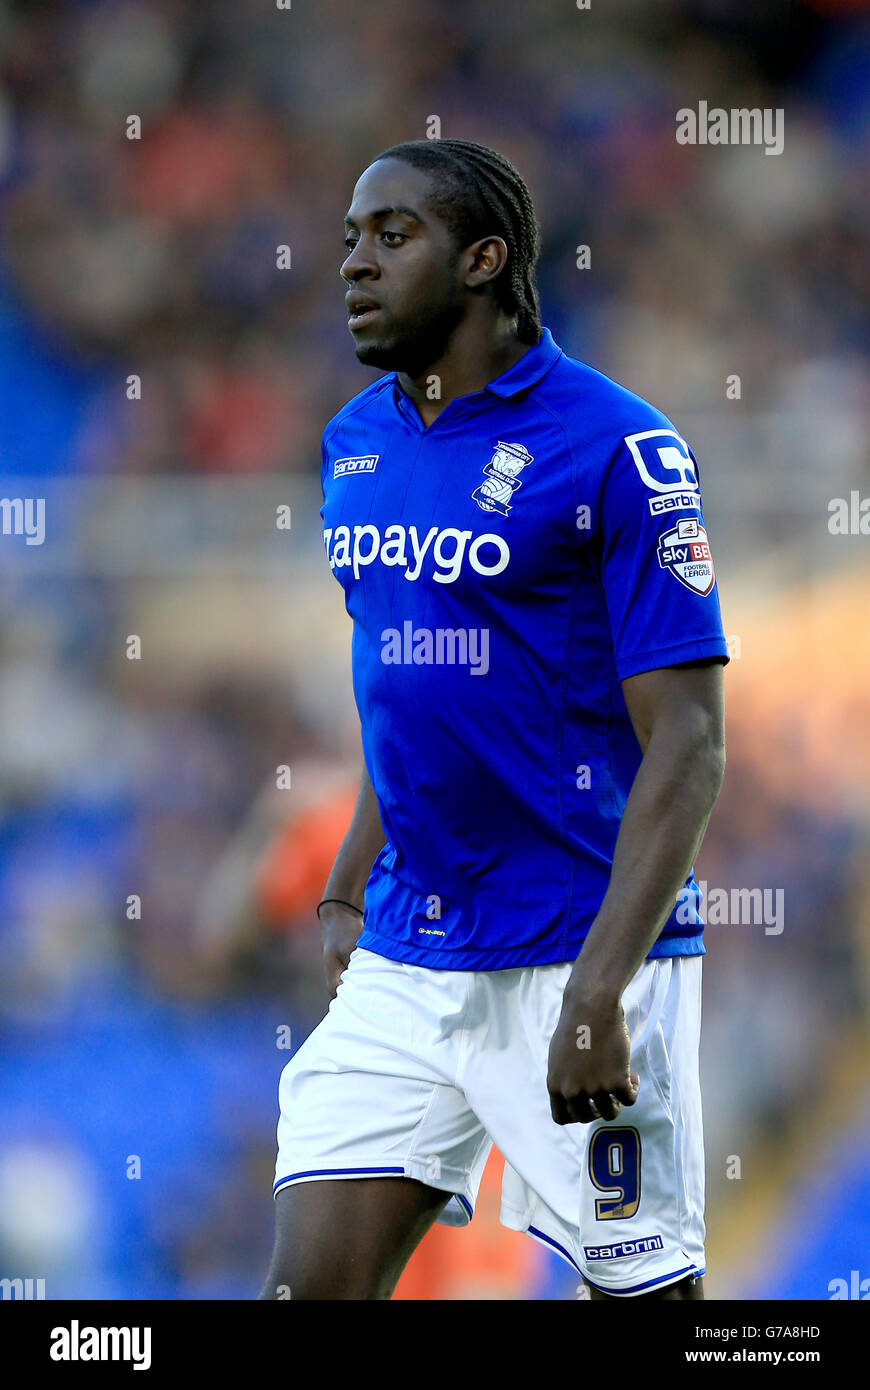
left=599, top=423, right=728, bottom=680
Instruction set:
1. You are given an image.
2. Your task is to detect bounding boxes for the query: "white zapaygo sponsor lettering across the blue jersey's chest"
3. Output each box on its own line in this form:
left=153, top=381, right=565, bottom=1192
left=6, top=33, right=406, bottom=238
left=324, top=524, right=510, bottom=584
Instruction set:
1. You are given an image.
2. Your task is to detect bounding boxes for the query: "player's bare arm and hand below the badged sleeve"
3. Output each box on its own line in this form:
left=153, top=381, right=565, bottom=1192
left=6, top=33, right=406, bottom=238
left=548, top=662, right=725, bottom=1125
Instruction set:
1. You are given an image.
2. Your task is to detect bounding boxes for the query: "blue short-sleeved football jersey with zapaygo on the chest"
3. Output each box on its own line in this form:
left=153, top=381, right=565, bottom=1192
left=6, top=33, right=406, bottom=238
left=321, top=329, right=727, bottom=970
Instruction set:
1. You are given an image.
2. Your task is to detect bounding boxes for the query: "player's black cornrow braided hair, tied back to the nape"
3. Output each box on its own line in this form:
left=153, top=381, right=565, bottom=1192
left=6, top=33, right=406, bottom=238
left=375, top=140, right=541, bottom=345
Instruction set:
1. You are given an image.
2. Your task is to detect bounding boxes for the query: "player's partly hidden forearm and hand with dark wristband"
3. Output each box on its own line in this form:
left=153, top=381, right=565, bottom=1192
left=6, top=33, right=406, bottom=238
left=320, top=767, right=386, bottom=998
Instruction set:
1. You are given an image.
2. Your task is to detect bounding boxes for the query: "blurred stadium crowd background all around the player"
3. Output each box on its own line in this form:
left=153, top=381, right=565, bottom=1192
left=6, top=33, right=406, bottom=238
left=0, top=0, right=870, bottom=1300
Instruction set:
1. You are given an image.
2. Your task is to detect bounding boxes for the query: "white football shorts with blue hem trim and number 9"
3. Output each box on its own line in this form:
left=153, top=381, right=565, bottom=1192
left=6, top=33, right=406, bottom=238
left=274, top=947, right=705, bottom=1295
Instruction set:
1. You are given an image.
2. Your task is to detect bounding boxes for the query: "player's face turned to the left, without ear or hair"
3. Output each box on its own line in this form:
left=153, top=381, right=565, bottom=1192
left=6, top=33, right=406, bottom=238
left=340, top=160, right=467, bottom=377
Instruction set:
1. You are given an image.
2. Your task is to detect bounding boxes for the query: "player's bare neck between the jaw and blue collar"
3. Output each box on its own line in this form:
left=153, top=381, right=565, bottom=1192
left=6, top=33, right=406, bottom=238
left=397, top=318, right=530, bottom=427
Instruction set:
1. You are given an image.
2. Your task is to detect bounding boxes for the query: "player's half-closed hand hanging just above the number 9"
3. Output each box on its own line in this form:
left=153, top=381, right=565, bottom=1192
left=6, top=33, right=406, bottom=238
left=546, top=991, right=641, bottom=1125
